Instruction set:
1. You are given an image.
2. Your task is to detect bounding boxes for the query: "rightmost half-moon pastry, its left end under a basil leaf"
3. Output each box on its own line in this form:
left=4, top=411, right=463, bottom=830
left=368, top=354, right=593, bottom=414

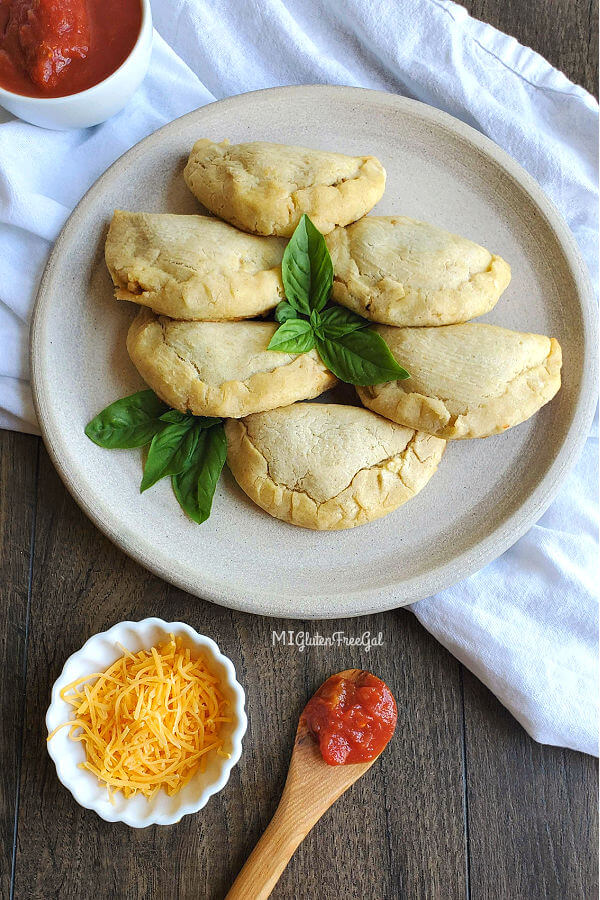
left=357, top=323, right=562, bottom=440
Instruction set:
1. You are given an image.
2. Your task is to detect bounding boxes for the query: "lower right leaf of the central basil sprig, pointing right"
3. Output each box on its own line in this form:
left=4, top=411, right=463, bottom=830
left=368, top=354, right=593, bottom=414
left=317, top=330, right=410, bottom=386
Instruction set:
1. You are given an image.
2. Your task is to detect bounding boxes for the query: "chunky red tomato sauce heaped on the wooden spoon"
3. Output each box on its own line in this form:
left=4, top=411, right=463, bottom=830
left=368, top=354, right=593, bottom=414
left=303, top=672, right=398, bottom=766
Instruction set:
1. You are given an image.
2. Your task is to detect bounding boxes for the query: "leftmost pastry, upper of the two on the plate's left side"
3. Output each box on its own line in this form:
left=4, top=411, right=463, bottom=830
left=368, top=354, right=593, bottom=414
left=105, top=209, right=286, bottom=321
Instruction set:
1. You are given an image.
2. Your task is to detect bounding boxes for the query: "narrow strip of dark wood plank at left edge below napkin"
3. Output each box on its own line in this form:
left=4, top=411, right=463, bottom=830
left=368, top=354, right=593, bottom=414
left=0, top=431, right=38, bottom=897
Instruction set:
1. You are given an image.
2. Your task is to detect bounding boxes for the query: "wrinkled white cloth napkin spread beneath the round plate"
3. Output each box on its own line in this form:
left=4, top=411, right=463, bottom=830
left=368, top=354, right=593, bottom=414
left=0, top=0, right=598, bottom=753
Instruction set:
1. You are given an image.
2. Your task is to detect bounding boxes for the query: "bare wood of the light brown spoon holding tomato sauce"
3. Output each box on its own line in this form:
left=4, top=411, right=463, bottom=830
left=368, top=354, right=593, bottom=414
left=225, top=669, right=390, bottom=900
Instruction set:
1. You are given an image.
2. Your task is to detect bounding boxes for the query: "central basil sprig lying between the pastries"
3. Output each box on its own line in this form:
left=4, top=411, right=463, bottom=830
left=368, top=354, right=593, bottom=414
left=267, top=215, right=410, bottom=386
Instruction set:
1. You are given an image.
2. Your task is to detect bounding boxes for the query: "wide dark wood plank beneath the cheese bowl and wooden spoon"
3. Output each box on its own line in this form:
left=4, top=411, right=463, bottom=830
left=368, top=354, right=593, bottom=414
left=15, top=452, right=466, bottom=900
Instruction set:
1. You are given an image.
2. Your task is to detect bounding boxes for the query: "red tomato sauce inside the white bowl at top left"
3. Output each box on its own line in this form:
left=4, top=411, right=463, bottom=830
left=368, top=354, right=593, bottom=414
left=0, top=0, right=142, bottom=97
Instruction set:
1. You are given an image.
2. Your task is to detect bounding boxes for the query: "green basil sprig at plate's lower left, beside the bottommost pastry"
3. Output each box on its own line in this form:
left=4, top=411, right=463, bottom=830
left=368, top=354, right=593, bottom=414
left=85, top=391, right=227, bottom=524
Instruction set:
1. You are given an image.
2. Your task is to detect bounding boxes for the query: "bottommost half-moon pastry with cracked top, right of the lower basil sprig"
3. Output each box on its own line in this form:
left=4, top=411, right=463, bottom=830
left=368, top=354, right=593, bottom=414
left=225, top=403, right=446, bottom=531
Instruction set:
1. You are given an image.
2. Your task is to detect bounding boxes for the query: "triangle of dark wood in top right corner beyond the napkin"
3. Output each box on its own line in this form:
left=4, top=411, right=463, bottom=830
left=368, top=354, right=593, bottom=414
left=461, top=0, right=598, bottom=97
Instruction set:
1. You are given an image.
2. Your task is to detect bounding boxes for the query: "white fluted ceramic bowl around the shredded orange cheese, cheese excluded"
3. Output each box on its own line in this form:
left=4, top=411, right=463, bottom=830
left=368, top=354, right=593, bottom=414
left=46, top=618, right=247, bottom=828
